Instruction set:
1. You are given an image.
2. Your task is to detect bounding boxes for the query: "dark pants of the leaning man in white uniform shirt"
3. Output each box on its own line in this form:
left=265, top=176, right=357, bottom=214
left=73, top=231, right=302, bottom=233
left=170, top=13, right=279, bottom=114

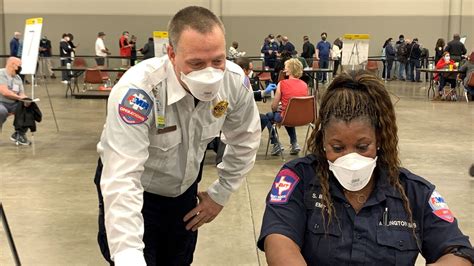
left=94, top=156, right=205, bottom=266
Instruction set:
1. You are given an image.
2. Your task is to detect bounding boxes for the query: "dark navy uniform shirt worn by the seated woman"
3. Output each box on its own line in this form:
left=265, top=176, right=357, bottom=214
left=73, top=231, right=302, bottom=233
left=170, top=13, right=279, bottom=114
left=258, top=155, right=471, bottom=265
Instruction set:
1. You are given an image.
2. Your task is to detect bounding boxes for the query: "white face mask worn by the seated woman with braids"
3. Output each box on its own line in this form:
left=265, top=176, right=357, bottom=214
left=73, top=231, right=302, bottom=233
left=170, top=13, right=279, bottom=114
left=328, top=152, right=377, bottom=191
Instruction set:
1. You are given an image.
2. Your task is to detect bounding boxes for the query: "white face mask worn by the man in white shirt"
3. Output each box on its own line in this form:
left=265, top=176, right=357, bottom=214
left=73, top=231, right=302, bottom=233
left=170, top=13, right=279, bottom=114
left=181, top=67, right=224, bottom=102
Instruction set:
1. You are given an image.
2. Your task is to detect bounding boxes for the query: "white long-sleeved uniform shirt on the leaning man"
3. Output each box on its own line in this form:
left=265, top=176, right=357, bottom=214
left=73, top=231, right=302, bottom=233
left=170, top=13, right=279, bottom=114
left=97, top=55, right=261, bottom=266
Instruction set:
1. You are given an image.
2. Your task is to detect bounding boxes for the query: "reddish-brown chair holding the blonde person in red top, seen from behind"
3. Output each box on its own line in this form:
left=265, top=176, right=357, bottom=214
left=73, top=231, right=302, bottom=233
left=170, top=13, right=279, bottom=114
left=265, top=95, right=316, bottom=160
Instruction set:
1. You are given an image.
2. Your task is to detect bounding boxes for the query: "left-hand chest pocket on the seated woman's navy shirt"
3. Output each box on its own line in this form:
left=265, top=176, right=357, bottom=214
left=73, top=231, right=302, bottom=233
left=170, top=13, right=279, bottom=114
left=302, top=211, right=341, bottom=265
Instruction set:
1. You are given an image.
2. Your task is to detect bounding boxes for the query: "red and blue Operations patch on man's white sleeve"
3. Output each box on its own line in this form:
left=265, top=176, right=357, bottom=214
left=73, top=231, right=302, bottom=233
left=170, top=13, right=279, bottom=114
left=118, top=88, right=153, bottom=125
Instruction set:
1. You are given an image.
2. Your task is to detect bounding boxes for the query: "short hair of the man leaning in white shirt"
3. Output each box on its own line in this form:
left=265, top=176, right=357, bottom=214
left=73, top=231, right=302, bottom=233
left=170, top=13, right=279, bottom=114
left=168, top=6, right=225, bottom=48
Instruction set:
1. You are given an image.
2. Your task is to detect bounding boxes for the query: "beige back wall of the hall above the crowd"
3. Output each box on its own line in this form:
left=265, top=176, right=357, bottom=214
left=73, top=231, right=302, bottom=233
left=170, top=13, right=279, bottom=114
left=0, top=0, right=474, bottom=55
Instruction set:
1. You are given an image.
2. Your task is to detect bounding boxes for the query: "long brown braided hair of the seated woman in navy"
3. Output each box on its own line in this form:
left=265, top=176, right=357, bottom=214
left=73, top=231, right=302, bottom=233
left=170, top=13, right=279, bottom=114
left=308, top=71, right=416, bottom=242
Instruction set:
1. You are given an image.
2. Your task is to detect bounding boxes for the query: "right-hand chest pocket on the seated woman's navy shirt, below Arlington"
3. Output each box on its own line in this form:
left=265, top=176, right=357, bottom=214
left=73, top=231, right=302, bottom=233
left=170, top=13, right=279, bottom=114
left=377, top=225, right=418, bottom=265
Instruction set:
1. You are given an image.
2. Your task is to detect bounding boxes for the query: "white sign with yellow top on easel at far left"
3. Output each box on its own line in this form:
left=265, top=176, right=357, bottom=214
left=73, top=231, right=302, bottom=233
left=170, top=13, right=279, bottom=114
left=21, top=18, right=43, bottom=75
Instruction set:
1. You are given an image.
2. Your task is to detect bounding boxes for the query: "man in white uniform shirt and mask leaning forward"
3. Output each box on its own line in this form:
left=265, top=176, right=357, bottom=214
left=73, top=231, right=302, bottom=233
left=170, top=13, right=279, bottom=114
left=94, top=6, right=261, bottom=266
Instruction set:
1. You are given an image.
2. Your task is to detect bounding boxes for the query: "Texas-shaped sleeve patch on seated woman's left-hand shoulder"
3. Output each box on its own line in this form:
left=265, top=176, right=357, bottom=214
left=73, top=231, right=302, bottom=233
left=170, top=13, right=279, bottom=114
left=268, top=169, right=300, bottom=204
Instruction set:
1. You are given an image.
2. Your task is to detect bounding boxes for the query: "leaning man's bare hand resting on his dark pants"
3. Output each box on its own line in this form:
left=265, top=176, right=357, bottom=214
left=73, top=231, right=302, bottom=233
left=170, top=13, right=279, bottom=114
left=183, top=192, right=224, bottom=231
